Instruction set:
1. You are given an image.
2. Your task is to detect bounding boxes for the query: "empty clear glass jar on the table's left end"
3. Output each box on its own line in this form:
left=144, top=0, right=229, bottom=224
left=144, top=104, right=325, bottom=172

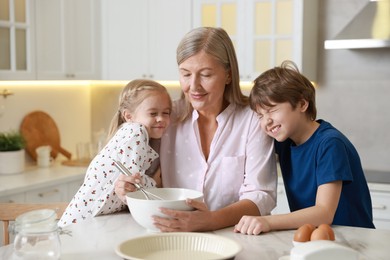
left=13, top=209, right=61, bottom=260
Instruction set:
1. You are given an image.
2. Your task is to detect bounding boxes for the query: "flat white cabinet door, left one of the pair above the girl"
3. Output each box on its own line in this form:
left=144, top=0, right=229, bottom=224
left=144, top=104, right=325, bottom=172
left=102, top=0, right=149, bottom=80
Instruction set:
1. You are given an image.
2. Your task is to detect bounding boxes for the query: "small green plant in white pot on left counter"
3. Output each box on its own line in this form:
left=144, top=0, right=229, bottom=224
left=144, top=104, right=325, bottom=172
left=0, top=131, right=26, bottom=174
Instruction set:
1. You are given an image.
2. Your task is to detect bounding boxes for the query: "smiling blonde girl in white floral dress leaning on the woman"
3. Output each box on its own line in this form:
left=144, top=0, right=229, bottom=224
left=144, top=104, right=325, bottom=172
left=59, top=80, right=172, bottom=226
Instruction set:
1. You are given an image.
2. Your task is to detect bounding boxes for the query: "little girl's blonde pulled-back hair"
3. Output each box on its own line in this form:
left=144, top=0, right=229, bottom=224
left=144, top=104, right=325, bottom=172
left=107, top=79, right=172, bottom=140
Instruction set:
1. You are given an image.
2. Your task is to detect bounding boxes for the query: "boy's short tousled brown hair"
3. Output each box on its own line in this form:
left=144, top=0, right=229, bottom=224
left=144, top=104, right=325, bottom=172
left=249, top=61, right=317, bottom=120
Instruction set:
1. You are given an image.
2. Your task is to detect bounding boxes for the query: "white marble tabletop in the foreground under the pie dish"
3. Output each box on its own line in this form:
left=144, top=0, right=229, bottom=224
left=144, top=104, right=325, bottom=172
left=0, top=213, right=390, bottom=260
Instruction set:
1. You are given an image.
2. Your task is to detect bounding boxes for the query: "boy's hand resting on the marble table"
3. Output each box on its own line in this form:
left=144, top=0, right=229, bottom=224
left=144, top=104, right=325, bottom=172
left=234, top=216, right=271, bottom=235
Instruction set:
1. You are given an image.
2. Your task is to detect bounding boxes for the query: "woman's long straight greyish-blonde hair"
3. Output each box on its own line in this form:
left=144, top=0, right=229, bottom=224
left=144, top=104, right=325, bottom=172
left=176, top=27, right=249, bottom=121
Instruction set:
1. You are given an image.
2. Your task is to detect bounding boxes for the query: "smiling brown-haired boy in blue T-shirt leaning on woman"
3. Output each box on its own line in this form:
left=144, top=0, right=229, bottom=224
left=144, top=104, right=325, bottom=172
left=235, top=61, right=374, bottom=235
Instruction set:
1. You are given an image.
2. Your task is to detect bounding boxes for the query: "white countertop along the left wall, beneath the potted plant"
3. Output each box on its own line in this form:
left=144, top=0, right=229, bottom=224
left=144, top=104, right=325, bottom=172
left=0, top=163, right=87, bottom=197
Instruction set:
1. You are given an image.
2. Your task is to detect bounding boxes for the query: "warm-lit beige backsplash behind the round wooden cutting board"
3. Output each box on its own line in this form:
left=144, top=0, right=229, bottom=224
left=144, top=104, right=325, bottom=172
left=0, top=81, right=91, bottom=161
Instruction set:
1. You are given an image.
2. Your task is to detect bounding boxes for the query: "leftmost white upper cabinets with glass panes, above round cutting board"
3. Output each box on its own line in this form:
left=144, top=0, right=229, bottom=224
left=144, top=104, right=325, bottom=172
left=0, top=0, right=101, bottom=80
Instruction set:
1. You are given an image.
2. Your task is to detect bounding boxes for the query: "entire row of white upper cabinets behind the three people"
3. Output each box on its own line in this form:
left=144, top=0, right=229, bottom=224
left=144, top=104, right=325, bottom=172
left=0, top=0, right=318, bottom=81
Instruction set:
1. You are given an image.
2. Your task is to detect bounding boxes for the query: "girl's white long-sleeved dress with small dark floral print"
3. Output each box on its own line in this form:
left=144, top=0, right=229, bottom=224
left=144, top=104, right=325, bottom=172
left=58, top=123, right=158, bottom=227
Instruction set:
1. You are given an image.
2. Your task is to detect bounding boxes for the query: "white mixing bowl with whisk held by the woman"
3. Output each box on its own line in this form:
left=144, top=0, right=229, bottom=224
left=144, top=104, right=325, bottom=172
left=126, top=188, right=203, bottom=232
